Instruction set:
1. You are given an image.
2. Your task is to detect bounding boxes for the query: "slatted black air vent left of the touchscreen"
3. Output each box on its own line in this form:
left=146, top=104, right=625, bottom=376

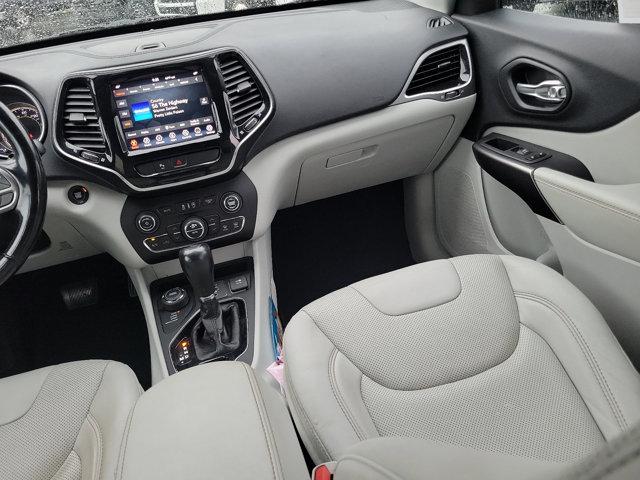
left=62, top=79, right=106, bottom=153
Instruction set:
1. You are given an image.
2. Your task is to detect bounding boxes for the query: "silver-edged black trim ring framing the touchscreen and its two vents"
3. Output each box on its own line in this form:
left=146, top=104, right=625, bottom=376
left=53, top=47, right=274, bottom=192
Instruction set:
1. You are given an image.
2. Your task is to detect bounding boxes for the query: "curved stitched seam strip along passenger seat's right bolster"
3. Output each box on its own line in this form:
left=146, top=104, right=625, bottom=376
left=514, top=292, right=627, bottom=430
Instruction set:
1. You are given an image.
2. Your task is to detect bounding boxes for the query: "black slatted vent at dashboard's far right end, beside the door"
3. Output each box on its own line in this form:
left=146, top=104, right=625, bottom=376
left=406, top=45, right=464, bottom=95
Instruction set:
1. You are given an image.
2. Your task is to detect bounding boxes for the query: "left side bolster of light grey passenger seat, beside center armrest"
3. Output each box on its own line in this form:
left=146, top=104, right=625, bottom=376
left=284, top=311, right=375, bottom=463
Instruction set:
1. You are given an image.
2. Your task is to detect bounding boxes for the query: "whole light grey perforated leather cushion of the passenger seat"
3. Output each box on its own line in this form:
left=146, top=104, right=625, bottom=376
left=285, top=255, right=640, bottom=462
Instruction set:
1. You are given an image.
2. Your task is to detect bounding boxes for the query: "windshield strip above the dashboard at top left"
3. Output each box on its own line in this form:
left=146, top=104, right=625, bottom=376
left=0, top=0, right=308, bottom=48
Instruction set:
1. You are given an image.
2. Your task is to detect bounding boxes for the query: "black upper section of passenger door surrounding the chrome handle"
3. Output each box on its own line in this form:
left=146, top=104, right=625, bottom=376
left=454, top=9, right=640, bottom=140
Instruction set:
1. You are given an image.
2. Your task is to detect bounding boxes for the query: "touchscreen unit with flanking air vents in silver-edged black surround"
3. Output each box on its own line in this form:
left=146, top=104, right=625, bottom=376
left=54, top=49, right=273, bottom=194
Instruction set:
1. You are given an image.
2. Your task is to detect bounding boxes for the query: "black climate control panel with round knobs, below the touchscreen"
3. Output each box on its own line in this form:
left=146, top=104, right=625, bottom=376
left=120, top=173, right=257, bottom=263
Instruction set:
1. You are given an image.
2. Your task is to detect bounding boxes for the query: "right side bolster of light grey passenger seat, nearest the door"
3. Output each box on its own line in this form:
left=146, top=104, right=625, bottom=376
left=501, top=257, right=640, bottom=440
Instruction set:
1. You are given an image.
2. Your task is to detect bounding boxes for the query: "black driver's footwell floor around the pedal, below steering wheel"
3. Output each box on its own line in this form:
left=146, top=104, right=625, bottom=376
left=0, top=255, right=151, bottom=388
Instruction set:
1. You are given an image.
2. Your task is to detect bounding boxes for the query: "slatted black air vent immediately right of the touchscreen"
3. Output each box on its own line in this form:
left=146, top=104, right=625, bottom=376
left=218, top=52, right=265, bottom=127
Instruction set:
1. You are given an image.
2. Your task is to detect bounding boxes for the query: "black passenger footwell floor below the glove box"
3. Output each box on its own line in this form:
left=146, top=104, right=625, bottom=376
left=271, top=182, right=414, bottom=326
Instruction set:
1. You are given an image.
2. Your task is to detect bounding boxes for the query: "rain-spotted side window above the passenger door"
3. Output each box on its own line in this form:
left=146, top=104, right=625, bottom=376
left=502, top=0, right=622, bottom=22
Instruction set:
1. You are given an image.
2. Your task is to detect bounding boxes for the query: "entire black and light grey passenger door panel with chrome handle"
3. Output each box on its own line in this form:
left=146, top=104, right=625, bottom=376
left=434, top=3, right=640, bottom=367
